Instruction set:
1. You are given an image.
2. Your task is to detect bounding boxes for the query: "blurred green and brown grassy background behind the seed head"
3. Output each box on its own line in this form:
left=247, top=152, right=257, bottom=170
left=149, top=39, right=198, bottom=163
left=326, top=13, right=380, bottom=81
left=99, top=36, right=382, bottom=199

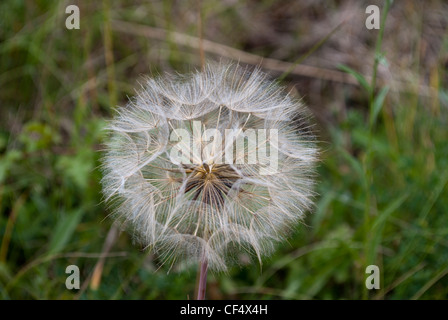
left=0, top=0, right=448, bottom=299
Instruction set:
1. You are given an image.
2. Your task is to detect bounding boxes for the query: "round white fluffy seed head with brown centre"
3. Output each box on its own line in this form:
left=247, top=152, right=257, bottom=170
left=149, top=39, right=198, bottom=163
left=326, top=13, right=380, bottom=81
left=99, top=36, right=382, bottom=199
left=102, top=63, right=317, bottom=271
